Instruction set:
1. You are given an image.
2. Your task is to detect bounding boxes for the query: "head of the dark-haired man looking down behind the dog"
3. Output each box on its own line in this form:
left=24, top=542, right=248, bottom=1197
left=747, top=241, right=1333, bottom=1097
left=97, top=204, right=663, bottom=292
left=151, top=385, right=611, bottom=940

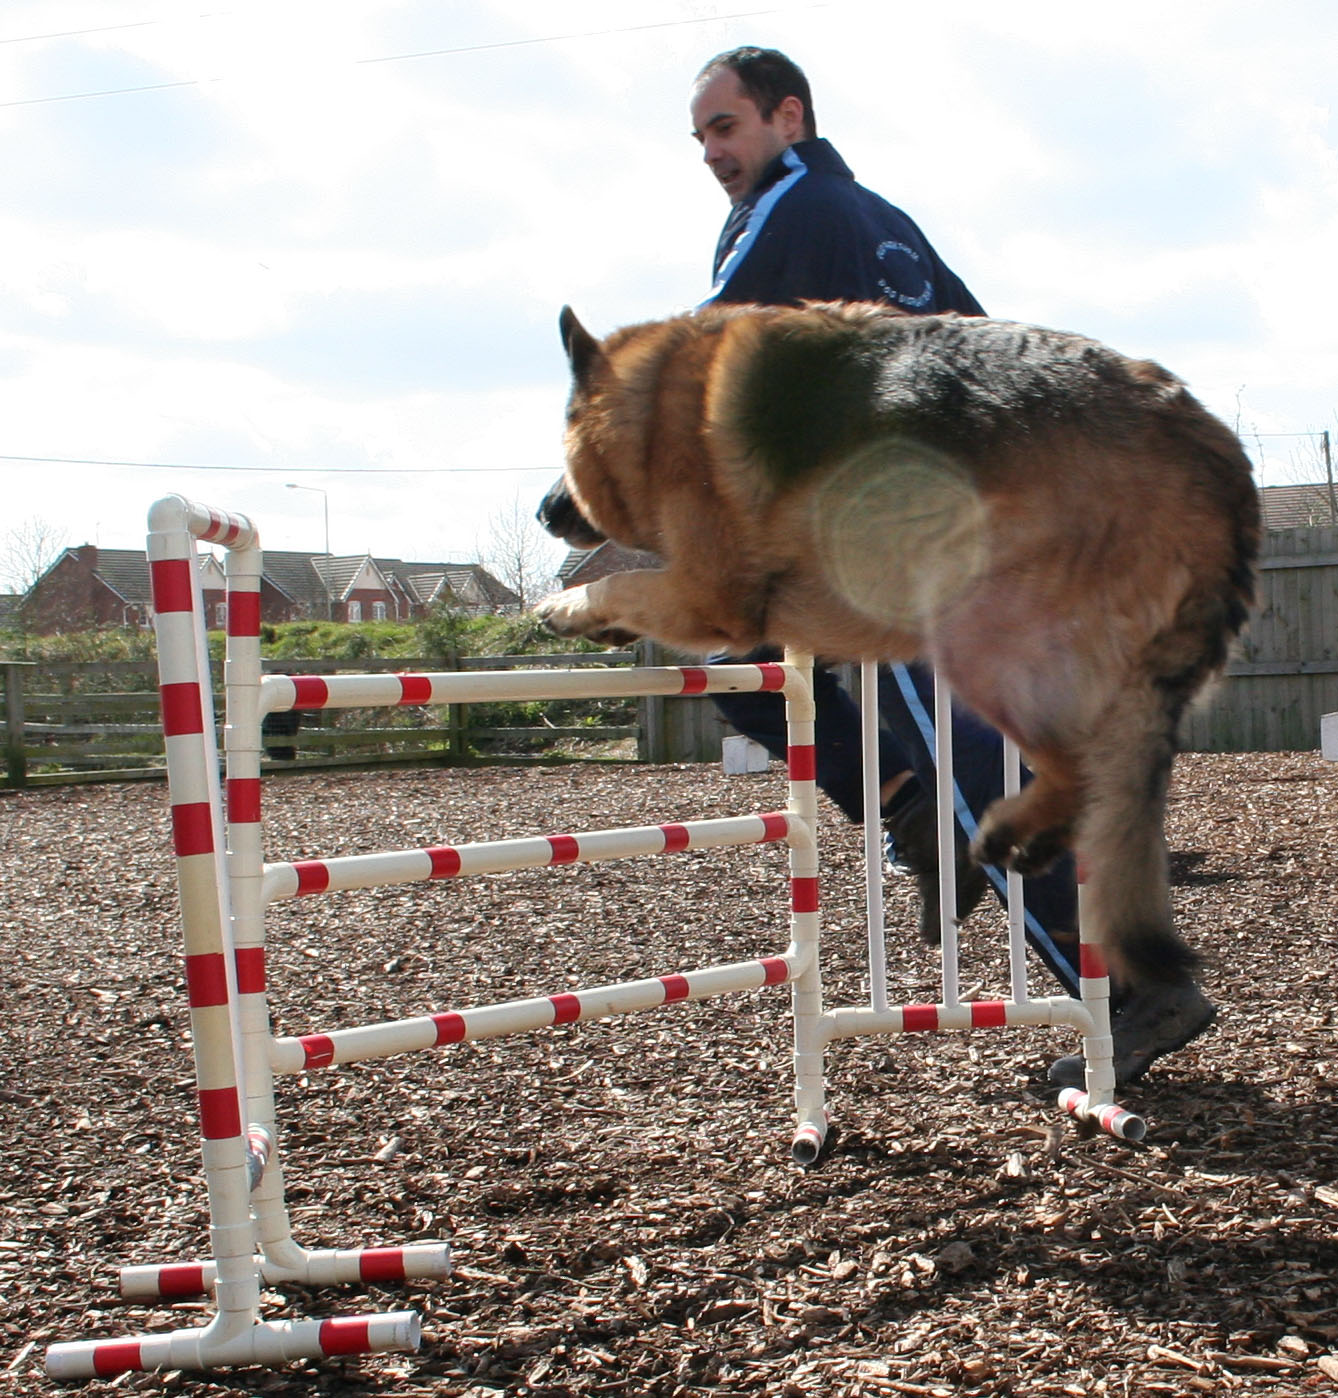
left=691, top=48, right=818, bottom=204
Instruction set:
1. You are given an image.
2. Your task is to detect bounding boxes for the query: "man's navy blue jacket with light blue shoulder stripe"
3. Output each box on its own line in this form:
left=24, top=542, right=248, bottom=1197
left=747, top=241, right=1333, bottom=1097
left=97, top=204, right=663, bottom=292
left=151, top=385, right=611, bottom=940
left=706, top=140, right=984, bottom=316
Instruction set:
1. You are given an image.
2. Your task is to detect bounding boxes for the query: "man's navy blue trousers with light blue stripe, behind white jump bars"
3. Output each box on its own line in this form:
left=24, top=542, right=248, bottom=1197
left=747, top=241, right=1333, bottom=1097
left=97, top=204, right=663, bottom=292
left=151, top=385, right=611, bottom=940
left=712, top=649, right=1078, bottom=995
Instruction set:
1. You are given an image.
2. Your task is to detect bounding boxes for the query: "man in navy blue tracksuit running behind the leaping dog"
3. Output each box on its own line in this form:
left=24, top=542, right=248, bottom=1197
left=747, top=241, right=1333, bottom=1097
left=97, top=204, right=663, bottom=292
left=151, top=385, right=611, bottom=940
left=691, top=48, right=1216, bottom=1086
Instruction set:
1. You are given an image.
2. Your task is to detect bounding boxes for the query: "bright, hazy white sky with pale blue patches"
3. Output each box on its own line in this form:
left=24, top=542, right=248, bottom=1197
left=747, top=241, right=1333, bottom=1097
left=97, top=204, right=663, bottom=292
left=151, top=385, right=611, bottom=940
left=0, top=0, right=1338, bottom=587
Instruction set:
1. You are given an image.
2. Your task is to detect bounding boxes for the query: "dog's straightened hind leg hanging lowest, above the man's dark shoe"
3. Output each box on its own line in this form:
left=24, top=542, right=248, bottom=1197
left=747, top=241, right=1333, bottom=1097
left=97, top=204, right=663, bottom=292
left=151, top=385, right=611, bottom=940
left=1075, top=681, right=1198, bottom=984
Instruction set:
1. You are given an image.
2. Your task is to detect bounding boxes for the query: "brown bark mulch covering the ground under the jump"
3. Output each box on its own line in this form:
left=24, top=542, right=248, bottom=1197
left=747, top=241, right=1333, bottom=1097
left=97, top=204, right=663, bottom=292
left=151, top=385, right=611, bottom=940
left=0, top=754, right=1338, bottom=1398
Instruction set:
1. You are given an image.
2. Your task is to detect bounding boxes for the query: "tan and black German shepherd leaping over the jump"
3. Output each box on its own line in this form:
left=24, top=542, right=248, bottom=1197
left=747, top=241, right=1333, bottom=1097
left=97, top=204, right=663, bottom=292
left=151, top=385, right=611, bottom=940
left=538, top=303, right=1260, bottom=984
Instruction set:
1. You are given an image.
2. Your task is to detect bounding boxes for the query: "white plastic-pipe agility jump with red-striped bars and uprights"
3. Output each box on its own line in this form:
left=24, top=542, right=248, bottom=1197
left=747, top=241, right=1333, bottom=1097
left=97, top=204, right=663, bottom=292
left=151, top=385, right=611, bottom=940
left=46, top=495, right=1144, bottom=1378
